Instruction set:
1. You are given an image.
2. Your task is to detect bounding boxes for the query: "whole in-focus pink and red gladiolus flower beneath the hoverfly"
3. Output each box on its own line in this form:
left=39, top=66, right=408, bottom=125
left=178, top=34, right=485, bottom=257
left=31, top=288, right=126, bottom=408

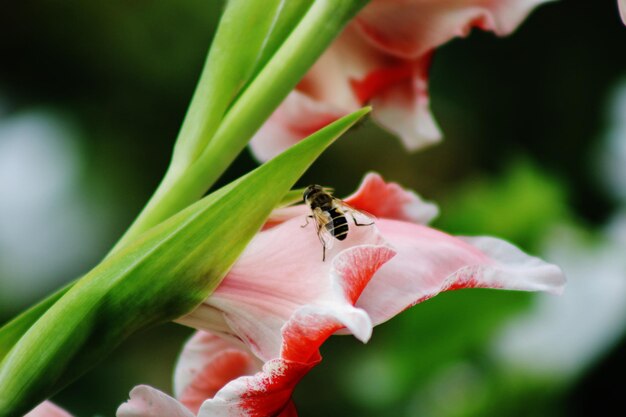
left=117, top=174, right=564, bottom=417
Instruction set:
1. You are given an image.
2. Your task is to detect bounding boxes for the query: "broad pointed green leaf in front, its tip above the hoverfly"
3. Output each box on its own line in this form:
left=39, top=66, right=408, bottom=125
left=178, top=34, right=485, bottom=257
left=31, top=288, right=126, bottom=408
left=0, top=109, right=369, bottom=417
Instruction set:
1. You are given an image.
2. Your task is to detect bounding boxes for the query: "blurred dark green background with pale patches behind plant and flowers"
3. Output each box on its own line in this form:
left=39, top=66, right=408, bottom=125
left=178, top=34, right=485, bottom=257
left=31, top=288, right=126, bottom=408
left=0, top=0, right=626, bottom=417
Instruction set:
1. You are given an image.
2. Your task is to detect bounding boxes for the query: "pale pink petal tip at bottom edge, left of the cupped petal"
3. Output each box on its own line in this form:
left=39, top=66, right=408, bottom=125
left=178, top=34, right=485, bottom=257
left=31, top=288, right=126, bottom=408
left=115, top=385, right=194, bottom=417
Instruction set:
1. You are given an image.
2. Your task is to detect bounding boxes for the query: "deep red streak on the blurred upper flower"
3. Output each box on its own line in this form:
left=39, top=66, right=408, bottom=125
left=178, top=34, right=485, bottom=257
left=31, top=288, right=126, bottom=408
left=350, top=61, right=413, bottom=104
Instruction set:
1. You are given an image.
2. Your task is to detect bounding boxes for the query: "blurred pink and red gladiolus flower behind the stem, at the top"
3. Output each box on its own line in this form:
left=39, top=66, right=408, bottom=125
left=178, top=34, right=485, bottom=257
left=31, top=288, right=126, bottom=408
left=250, top=0, right=545, bottom=161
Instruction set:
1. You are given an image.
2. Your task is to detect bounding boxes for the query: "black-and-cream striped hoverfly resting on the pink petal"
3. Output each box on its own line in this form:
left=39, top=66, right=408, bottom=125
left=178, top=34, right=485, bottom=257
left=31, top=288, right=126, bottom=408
left=302, top=185, right=374, bottom=262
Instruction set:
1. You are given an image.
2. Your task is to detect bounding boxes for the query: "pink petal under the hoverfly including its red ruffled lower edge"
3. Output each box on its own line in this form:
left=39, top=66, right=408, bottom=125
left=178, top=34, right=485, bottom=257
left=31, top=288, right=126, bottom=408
left=182, top=232, right=395, bottom=417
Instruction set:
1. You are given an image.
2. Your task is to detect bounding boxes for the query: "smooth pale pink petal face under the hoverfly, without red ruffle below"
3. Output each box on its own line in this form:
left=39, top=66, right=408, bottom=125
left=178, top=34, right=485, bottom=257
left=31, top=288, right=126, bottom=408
left=181, top=216, right=394, bottom=360
